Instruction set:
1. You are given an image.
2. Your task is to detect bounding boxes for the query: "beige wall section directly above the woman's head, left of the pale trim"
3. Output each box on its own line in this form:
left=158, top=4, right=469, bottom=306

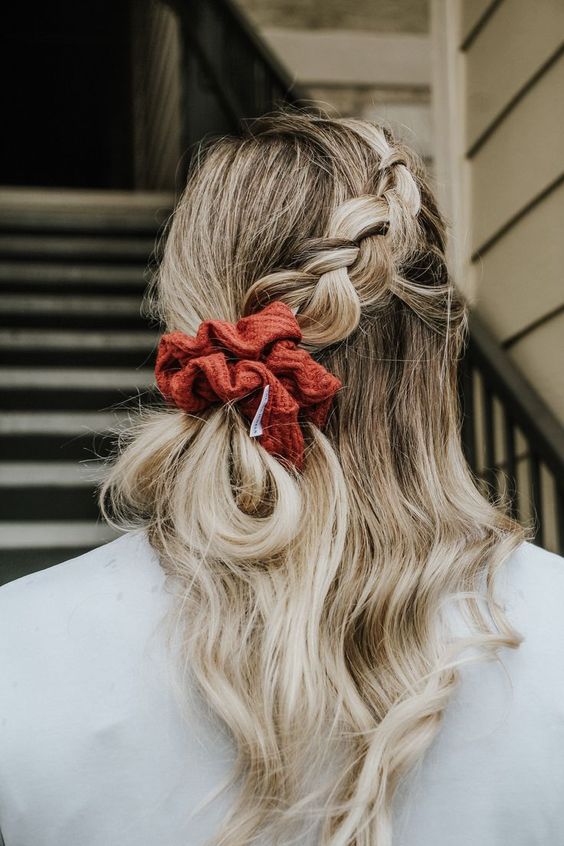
left=234, top=0, right=433, bottom=162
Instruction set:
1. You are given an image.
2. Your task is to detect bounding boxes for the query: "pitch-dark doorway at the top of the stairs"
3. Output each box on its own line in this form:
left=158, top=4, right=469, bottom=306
left=0, top=0, right=133, bottom=189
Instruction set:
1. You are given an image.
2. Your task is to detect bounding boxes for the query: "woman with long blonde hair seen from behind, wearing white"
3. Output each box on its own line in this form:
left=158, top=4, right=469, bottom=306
left=0, top=112, right=564, bottom=846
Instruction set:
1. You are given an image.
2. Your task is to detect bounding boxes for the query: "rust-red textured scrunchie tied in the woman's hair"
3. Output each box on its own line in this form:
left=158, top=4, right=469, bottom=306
left=155, top=300, right=341, bottom=470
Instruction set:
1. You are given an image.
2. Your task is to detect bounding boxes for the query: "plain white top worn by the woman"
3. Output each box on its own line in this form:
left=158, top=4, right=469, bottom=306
left=0, top=533, right=564, bottom=846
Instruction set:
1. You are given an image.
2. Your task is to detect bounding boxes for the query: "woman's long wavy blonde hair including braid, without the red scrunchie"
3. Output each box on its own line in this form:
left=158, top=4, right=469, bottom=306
left=102, top=110, right=524, bottom=846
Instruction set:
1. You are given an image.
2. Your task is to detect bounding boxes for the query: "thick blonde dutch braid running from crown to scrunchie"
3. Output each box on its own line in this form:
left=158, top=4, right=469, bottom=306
left=243, top=121, right=448, bottom=350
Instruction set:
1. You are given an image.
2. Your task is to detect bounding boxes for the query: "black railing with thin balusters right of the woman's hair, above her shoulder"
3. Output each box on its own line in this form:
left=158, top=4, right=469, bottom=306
left=460, top=315, right=564, bottom=552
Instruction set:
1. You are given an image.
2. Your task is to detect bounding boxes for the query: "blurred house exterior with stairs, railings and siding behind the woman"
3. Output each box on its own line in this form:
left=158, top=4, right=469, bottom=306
left=0, top=0, right=564, bottom=582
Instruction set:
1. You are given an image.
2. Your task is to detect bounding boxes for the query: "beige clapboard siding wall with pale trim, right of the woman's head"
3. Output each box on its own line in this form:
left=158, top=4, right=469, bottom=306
left=436, top=0, right=564, bottom=422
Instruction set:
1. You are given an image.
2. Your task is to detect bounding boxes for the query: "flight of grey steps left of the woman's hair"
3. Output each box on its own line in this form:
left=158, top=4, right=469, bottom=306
left=0, top=189, right=172, bottom=582
